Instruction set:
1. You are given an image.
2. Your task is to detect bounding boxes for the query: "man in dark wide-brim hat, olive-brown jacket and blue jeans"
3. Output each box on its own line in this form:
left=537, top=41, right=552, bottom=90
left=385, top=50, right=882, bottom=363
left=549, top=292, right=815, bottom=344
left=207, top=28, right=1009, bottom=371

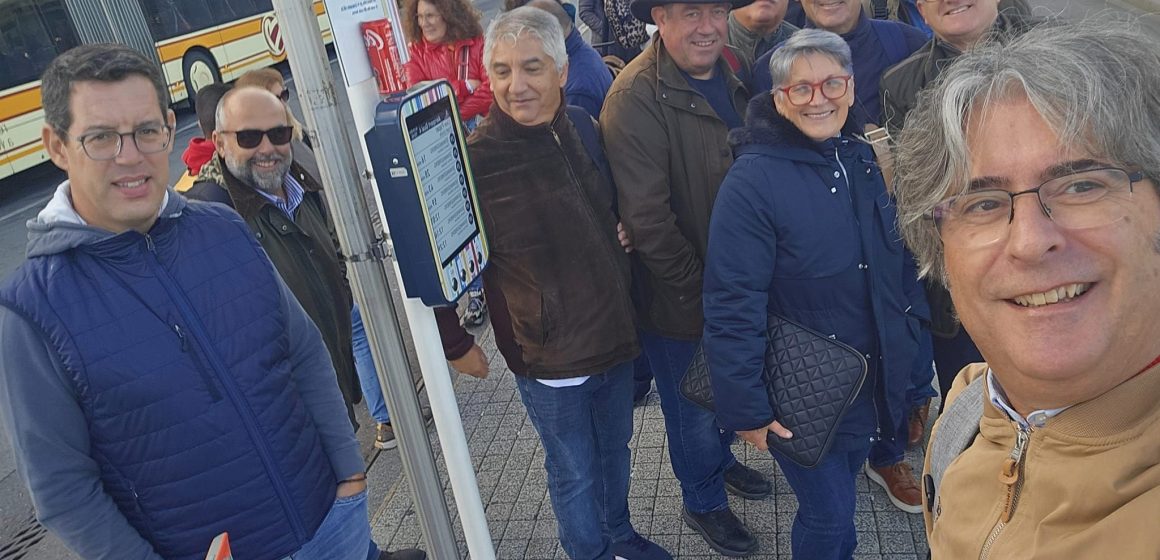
left=600, top=0, right=771, bottom=557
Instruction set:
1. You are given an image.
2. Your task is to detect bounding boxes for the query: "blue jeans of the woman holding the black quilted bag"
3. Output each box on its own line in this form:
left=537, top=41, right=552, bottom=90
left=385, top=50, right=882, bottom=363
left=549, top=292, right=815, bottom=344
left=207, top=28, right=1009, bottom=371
left=773, top=442, right=870, bottom=560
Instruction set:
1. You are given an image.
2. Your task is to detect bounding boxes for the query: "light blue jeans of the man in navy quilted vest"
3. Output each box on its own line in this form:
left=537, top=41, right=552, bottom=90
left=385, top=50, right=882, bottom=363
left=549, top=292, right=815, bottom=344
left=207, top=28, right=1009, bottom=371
left=289, top=490, right=379, bottom=560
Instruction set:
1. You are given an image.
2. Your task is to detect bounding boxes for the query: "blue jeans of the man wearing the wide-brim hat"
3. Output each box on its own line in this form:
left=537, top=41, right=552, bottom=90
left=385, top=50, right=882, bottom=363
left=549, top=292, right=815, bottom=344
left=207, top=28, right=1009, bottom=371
left=640, top=332, right=737, bottom=514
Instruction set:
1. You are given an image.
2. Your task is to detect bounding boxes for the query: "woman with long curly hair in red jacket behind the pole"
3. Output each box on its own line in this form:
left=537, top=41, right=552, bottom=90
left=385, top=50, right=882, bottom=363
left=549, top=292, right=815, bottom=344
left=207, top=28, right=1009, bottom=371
left=403, top=0, right=492, bottom=122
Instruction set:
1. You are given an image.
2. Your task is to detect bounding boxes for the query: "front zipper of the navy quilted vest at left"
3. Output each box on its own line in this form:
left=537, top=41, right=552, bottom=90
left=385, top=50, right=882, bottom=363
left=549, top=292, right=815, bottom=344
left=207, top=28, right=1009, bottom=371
left=145, top=234, right=306, bottom=543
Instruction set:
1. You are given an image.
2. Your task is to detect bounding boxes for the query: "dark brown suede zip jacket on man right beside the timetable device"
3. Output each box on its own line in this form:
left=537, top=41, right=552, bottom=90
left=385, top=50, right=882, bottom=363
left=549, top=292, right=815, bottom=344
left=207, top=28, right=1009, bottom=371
left=440, top=103, right=640, bottom=379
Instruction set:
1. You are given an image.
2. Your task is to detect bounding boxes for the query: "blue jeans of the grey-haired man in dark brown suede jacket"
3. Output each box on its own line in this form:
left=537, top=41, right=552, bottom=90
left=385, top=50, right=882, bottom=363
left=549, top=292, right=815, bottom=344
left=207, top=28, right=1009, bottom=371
left=515, top=362, right=633, bottom=560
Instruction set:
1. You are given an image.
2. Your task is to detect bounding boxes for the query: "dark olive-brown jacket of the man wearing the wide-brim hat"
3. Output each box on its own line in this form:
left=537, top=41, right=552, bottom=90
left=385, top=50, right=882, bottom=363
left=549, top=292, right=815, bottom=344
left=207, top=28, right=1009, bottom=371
left=600, top=35, right=748, bottom=340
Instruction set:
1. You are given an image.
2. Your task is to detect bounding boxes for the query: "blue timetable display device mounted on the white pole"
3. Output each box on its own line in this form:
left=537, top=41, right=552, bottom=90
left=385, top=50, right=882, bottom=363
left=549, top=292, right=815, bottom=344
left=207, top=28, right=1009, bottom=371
left=367, top=80, right=488, bottom=306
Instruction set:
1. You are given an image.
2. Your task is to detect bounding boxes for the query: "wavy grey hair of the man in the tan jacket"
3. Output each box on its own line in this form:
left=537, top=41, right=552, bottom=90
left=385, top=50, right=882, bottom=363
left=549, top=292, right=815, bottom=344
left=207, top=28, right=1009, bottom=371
left=894, top=17, right=1160, bottom=285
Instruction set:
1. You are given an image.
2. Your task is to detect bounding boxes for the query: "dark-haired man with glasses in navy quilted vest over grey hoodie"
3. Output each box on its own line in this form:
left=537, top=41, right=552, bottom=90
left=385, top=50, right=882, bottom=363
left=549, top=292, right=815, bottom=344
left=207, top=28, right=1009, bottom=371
left=0, top=44, right=421, bottom=560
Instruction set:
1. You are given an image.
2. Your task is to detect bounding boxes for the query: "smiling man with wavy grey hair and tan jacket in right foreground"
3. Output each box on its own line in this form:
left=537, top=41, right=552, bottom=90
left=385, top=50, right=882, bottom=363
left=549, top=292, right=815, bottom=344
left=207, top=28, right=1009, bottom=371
left=894, top=21, right=1160, bottom=558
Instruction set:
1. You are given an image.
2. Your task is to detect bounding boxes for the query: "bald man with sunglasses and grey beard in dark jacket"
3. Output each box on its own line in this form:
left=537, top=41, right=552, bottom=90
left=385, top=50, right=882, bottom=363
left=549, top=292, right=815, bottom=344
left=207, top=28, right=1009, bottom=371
left=186, top=87, right=362, bottom=429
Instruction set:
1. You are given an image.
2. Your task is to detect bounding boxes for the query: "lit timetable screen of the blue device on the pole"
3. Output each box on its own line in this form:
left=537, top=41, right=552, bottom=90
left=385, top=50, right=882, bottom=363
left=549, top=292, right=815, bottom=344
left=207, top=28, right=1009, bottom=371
left=406, top=97, right=478, bottom=267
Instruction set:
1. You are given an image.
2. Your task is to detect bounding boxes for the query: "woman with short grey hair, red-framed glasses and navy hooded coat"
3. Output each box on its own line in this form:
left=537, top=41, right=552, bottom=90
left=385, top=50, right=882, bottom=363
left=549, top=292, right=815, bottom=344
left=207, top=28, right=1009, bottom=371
left=703, top=29, right=929, bottom=560
